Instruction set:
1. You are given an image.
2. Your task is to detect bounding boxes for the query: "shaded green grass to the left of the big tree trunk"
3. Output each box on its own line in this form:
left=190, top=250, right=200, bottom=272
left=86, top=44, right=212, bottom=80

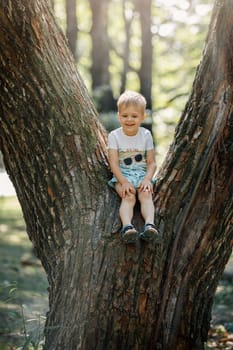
left=0, top=197, right=48, bottom=350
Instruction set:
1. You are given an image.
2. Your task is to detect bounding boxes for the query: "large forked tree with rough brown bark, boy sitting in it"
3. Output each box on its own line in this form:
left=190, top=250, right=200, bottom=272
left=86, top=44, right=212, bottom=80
left=0, top=0, right=233, bottom=350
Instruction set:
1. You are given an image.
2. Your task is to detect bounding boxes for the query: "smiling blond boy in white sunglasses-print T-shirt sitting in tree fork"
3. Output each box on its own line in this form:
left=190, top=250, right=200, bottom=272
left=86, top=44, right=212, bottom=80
left=108, top=91, right=158, bottom=243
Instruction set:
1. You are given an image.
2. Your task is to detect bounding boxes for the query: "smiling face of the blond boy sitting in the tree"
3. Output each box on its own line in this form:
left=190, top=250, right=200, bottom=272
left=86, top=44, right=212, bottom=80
left=118, top=105, right=145, bottom=136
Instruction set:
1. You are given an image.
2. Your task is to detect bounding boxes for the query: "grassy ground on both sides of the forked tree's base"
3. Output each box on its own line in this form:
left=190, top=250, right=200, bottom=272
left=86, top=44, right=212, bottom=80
left=0, top=196, right=233, bottom=350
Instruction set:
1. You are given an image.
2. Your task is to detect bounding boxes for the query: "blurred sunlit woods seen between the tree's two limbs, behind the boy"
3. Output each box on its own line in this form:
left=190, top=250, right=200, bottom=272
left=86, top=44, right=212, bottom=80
left=52, top=0, right=213, bottom=164
